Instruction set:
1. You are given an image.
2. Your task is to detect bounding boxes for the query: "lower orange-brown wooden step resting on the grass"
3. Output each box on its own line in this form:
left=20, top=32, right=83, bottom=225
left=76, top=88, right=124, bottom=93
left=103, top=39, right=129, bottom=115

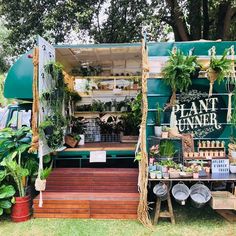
left=34, top=192, right=139, bottom=219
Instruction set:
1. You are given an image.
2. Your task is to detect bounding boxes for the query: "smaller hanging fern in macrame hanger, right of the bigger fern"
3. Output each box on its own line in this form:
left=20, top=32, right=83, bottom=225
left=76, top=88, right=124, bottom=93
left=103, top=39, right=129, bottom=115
left=207, top=49, right=232, bottom=96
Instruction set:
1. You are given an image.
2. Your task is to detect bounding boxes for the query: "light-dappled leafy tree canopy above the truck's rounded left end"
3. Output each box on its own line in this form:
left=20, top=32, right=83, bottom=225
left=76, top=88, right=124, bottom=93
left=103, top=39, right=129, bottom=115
left=0, top=0, right=100, bottom=53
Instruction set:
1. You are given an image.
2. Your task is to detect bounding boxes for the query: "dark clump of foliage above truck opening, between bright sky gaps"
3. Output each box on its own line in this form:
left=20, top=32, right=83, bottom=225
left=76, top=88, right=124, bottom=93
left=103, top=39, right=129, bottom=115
left=90, top=0, right=155, bottom=43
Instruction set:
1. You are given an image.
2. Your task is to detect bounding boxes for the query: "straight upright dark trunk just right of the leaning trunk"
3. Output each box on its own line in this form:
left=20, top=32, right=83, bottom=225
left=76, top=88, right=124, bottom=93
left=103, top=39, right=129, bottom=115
left=188, top=0, right=202, bottom=40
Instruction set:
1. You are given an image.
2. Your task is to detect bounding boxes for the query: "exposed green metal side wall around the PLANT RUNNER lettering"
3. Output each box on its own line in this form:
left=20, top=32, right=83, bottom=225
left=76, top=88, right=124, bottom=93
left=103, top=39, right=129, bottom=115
left=147, top=42, right=236, bottom=151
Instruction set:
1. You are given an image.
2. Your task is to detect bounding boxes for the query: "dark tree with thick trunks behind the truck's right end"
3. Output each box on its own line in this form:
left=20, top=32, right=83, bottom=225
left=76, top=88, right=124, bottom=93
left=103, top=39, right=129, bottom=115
left=152, top=0, right=236, bottom=41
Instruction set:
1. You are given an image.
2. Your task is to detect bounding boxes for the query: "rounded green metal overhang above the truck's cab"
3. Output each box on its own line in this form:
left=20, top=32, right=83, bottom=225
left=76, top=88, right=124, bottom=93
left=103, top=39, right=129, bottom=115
left=4, top=51, right=33, bottom=100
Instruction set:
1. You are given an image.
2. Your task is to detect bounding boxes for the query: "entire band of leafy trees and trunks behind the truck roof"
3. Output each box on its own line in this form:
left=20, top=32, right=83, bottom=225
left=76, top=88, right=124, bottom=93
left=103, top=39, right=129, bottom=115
left=0, top=0, right=236, bottom=53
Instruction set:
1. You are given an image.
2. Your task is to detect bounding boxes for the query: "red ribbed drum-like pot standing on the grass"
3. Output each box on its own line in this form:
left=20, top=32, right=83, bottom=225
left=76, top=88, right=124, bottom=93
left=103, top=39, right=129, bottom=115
left=11, top=196, right=30, bottom=222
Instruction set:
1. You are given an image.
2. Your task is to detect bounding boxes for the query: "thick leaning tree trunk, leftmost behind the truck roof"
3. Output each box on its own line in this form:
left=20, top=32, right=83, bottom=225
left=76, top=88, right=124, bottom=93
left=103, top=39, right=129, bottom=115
left=166, top=0, right=189, bottom=41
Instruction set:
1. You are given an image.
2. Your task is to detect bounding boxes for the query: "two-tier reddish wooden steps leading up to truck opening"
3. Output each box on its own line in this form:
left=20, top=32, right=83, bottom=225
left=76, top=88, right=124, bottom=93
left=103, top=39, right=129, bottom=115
left=33, top=168, right=139, bottom=219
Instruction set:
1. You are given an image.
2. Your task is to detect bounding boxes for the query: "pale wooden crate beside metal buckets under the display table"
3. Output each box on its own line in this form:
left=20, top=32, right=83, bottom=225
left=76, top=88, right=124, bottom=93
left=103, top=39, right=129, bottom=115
left=210, top=191, right=236, bottom=210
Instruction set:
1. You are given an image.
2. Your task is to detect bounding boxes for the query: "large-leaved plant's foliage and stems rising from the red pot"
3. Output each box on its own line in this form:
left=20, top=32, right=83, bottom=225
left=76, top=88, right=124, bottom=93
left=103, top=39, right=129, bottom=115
left=0, top=127, right=38, bottom=197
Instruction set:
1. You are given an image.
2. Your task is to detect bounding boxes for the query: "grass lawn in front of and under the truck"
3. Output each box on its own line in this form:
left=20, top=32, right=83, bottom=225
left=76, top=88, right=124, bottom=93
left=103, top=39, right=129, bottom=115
left=0, top=204, right=236, bottom=236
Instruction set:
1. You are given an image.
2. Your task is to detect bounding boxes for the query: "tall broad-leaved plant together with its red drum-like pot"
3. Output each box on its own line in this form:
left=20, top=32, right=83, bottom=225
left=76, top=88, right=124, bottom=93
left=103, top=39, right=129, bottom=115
left=0, top=127, right=34, bottom=222
